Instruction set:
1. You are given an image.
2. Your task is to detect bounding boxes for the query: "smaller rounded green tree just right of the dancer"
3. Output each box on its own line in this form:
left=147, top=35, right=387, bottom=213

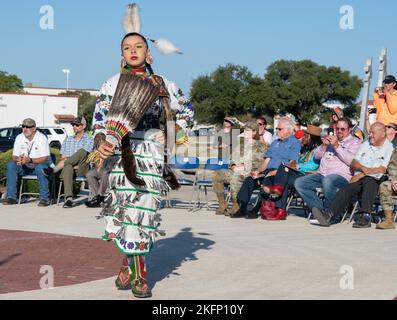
left=190, top=64, right=262, bottom=123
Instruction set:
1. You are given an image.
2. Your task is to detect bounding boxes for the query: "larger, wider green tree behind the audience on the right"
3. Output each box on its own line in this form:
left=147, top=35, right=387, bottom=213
left=259, top=60, right=362, bottom=124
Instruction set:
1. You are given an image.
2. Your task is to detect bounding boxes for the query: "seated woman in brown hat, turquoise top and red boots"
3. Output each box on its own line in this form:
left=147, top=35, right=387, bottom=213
left=262, top=125, right=322, bottom=216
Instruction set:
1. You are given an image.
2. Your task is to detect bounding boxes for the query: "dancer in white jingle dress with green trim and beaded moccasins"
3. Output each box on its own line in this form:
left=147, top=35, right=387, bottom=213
left=93, top=4, right=185, bottom=298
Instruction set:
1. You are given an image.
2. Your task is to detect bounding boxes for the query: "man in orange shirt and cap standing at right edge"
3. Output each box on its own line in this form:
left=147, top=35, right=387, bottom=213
left=374, top=75, right=397, bottom=126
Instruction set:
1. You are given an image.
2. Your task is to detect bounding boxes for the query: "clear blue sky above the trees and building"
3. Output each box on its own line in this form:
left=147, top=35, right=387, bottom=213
left=0, top=0, right=397, bottom=93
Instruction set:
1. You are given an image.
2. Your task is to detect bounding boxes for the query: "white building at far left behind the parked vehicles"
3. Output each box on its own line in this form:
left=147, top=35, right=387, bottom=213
left=0, top=92, right=78, bottom=134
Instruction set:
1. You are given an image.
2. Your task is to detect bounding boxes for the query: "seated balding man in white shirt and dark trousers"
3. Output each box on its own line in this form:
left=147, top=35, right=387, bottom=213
left=313, top=122, right=393, bottom=228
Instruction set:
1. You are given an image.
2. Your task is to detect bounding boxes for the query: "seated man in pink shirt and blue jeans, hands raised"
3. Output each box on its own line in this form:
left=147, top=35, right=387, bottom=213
left=295, top=118, right=361, bottom=218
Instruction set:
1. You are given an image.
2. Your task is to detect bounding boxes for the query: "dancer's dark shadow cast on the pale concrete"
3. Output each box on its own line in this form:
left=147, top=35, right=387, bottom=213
left=147, top=228, right=215, bottom=288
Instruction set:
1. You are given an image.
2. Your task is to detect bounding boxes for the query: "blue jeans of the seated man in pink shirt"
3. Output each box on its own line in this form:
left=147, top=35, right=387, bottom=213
left=295, top=174, right=349, bottom=210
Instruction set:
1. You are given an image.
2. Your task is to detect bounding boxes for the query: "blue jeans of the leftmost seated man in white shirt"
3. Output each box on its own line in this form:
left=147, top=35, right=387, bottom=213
left=7, top=161, right=50, bottom=201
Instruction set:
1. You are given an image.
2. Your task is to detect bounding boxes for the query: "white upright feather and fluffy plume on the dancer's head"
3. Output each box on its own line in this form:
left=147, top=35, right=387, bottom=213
left=123, top=3, right=183, bottom=54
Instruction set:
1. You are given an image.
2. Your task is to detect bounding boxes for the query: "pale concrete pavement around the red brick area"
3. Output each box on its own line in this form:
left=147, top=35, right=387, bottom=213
left=0, top=189, right=397, bottom=300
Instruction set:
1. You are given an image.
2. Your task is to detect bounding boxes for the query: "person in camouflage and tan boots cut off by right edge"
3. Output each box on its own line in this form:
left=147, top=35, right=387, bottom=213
left=376, top=149, right=397, bottom=230
